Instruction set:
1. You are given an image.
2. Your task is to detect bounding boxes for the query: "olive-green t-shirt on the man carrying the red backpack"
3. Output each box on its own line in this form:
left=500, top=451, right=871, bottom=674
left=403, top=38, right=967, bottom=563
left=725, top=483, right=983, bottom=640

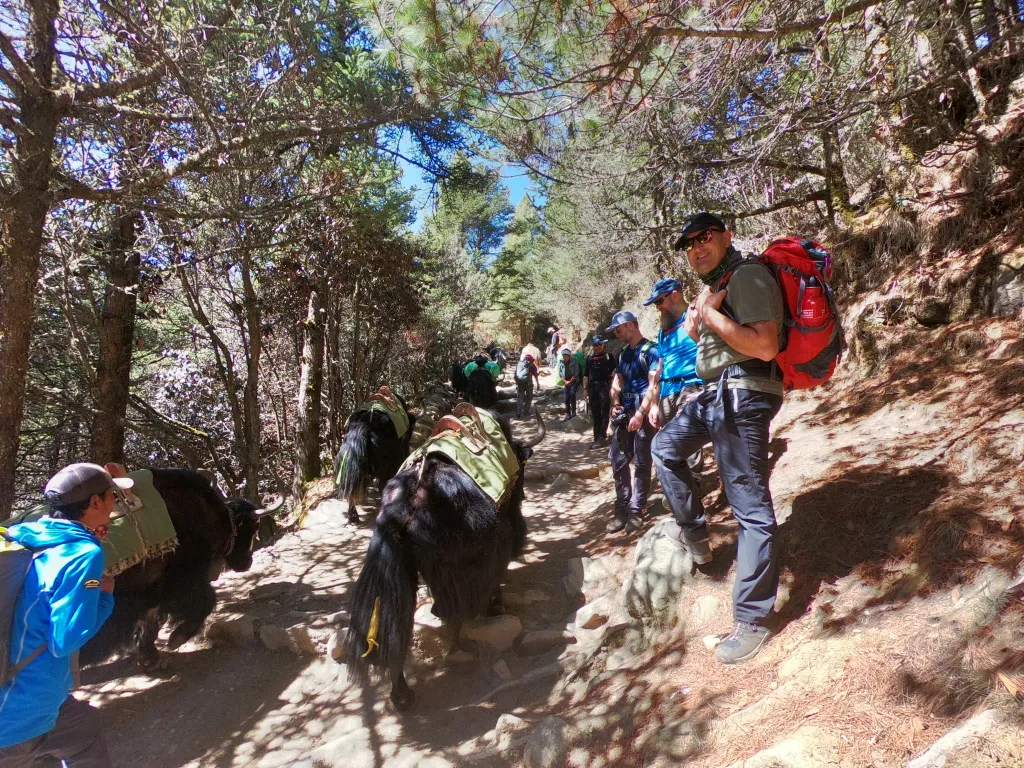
left=697, top=250, right=785, bottom=394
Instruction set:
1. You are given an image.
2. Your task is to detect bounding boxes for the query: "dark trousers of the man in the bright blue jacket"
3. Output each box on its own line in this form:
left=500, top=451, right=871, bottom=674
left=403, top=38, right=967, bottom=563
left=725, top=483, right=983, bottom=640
left=0, top=696, right=114, bottom=768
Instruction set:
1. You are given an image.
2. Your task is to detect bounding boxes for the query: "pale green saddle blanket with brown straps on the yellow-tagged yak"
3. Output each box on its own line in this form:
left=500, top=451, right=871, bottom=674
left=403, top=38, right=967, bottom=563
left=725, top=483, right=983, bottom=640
left=402, top=402, right=519, bottom=506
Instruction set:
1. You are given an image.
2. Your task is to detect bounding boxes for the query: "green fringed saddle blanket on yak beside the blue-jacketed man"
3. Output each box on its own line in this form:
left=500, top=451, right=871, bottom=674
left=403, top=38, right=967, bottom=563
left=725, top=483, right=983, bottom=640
left=0, top=469, right=178, bottom=577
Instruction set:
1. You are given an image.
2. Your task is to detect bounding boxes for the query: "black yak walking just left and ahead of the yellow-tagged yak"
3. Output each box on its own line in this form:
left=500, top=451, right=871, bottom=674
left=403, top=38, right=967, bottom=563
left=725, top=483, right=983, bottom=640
left=334, top=387, right=416, bottom=522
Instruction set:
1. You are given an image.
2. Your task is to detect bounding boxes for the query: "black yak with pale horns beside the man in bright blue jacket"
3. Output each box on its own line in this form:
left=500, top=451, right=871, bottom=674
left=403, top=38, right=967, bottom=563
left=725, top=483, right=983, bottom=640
left=81, top=469, right=283, bottom=668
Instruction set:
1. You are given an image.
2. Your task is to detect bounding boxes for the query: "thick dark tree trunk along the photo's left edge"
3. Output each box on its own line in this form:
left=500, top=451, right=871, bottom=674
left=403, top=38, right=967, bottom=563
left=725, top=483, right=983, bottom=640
left=0, top=0, right=60, bottom=518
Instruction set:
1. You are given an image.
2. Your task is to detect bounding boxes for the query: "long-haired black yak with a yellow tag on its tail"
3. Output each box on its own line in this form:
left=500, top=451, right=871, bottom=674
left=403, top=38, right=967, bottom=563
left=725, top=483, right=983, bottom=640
left=345, top=404, right=545, bottom=711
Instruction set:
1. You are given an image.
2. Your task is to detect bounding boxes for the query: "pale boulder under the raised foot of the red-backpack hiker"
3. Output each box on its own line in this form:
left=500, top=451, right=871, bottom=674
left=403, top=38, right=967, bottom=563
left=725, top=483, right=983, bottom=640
left=623, top=519, right=694, bottom=618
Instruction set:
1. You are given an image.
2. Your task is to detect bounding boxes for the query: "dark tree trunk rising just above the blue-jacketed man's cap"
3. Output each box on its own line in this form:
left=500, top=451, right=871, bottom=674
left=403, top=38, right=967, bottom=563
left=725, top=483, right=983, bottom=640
left=91, top=211, right=141, bottom=464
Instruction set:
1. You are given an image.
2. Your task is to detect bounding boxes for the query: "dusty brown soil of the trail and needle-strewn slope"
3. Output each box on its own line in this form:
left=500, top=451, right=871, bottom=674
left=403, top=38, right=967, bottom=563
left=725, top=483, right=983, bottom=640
left=81, top=322, right=1024, bottom=768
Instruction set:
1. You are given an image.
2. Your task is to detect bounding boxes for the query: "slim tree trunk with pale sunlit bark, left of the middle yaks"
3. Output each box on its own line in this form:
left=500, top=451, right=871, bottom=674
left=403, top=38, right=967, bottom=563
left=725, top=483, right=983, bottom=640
left=293, top=290, right=324, bottom=498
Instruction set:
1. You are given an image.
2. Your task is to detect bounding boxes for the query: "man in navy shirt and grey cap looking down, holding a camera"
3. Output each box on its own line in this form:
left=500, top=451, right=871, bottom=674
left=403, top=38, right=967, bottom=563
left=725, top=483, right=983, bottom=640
left=607, top=310, right=660, bottom=534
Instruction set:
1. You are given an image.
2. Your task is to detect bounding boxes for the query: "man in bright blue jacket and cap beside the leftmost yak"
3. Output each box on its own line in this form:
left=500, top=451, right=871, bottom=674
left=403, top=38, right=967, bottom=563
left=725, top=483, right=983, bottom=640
left=0, top=464, right=132, bottom=768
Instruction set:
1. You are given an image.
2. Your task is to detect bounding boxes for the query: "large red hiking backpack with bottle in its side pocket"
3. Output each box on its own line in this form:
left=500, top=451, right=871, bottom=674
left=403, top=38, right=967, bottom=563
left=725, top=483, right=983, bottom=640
left=720, top=238, right=843, bottom=391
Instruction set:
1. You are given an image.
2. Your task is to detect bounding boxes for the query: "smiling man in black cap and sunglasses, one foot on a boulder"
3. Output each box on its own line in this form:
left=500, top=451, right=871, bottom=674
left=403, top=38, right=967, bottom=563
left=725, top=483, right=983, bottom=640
left=652, top=211, right=784, bottom=664
